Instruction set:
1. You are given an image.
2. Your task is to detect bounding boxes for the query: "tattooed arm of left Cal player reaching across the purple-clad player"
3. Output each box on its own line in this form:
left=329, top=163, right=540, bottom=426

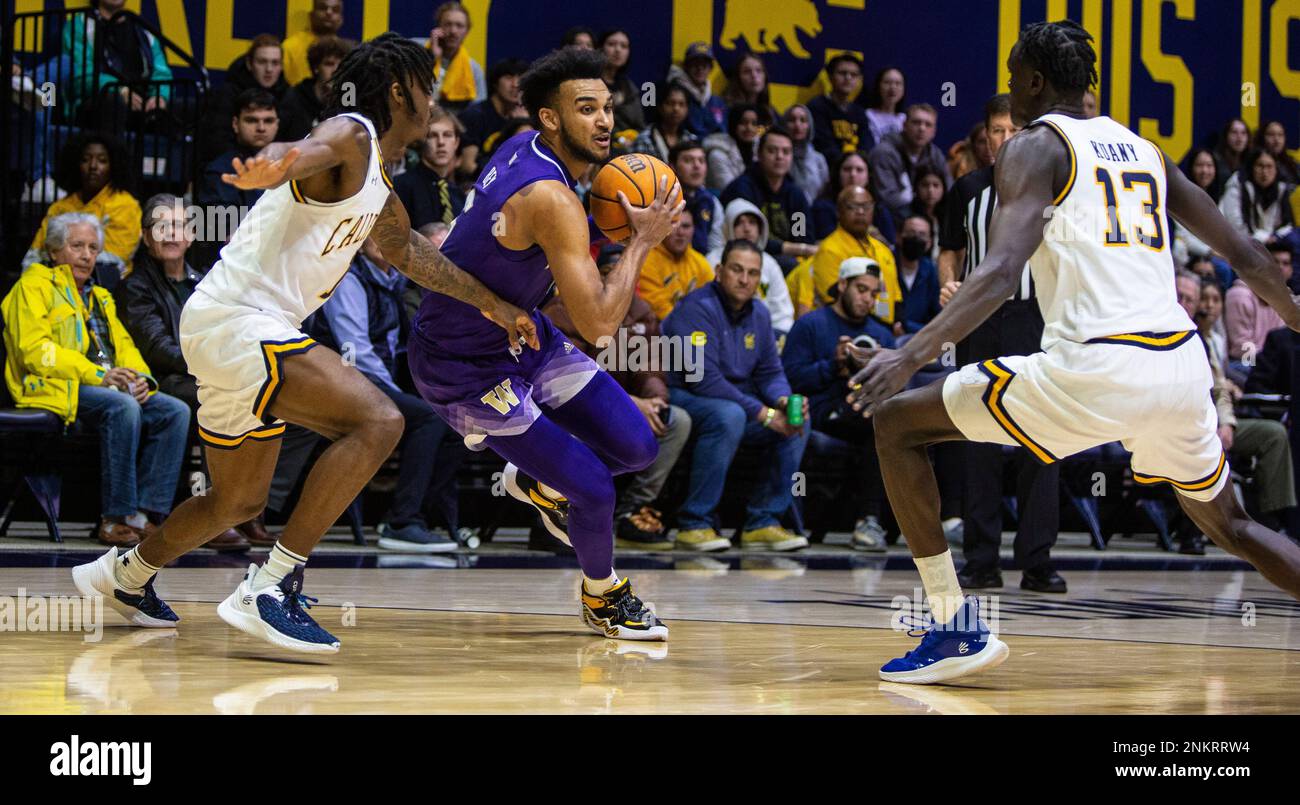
left=371, top=192, right=541, bottom=351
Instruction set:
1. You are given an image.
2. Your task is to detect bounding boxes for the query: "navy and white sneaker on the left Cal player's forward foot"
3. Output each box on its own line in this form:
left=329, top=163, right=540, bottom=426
left=217, top=564, right=339, bottom=654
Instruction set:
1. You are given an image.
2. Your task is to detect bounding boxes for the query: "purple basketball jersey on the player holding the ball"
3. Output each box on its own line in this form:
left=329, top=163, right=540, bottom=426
left=415, top=131, right=577, bottom=356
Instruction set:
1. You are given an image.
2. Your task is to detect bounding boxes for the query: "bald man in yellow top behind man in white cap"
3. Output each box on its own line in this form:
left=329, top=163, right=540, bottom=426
left=790, top=186, right=902, bottom=318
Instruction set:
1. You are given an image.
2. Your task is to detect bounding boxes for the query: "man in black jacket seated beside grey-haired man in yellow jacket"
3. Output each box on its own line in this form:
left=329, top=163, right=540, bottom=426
left=114, top=192, right=253, bottom=553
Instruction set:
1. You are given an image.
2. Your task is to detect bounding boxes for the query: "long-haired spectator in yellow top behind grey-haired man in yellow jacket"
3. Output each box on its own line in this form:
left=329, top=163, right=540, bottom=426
left=22, top=131, right=140, bottom=274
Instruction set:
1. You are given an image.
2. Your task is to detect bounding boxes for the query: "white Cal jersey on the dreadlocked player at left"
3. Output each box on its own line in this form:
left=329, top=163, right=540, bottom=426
left=198, top=113, right=393, bottom=328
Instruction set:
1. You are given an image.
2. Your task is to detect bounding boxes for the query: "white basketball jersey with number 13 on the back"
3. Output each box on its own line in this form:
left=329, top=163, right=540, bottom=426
left=1030, top=114, right=1195, bottom=350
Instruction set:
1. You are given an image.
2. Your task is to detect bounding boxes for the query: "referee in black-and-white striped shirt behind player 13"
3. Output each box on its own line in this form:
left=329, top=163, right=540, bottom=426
left=939, top=95, right=1066, bottom=593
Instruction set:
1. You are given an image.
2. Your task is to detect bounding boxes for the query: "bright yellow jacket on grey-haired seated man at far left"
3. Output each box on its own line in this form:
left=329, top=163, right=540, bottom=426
left=0, top=263, right=157, bottom=424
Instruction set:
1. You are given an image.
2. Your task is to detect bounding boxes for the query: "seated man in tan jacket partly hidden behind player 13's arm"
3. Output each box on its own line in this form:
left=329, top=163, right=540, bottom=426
left=1177, top=272, right=1296, bottom=554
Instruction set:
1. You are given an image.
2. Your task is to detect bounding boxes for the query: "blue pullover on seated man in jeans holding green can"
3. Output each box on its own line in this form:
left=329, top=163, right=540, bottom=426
left=663, top=281, right=790, bottom=417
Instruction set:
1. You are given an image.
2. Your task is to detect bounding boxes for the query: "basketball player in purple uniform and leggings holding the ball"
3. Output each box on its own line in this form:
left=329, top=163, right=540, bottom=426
left=408, top=48, right=685, bottom=640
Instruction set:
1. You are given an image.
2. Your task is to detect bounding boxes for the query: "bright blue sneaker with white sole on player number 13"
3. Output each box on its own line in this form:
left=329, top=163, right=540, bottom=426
left=880, top=597, right=1010, bottom=685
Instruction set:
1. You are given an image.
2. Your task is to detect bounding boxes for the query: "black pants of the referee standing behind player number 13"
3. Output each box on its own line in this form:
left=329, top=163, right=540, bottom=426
left=957, top=302, right=1061, bottom=571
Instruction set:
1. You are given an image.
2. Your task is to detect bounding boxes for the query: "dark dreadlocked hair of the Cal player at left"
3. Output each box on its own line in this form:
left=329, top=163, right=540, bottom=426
left=322, top=31, right=434, bottom=134
